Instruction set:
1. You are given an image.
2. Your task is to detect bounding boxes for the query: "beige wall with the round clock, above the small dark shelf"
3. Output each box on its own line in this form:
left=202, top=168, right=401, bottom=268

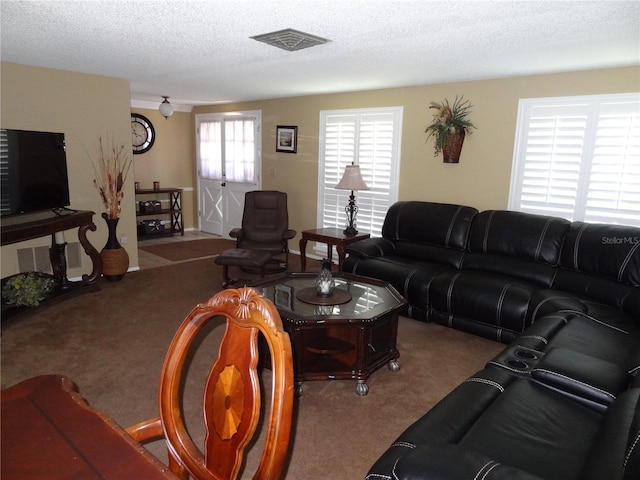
left=131, top=108, right=198, bottom=229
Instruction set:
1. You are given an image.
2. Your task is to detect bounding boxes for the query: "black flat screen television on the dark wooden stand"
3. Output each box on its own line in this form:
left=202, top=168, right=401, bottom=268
left=0, top=129, right=70, bottom=216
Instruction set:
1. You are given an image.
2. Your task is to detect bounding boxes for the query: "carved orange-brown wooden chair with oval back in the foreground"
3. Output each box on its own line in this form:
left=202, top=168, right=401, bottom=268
left=127, top=287, right=293, bottom=480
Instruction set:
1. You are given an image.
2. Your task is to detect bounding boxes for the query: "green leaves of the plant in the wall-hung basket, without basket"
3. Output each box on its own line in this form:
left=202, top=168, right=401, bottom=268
left=425, top=95, right=476, bottom=157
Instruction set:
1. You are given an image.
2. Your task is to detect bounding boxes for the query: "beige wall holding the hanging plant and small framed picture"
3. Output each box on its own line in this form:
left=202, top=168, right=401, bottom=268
left=194, top=67, right=640, bottom=248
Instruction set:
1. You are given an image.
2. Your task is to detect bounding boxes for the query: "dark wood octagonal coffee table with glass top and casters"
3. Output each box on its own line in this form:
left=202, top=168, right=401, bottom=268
left=252, top=272, right=406, bottom=395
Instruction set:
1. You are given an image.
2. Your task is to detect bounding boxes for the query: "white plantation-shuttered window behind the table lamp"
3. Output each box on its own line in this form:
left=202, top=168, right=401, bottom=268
left=318, top=107, right=403, bottom=237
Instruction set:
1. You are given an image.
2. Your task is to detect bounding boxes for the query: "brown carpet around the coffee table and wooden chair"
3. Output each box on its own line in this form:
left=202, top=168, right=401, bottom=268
left=1, top=255, right=504, bottom=480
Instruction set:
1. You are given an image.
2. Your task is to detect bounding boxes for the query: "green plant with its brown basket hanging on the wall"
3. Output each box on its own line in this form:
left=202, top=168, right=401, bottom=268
left=425, top=96, right=476, bottom=163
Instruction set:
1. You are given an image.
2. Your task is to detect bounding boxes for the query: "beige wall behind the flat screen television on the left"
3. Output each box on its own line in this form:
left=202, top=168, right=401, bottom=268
left=0, top=62, right=138, bottom=278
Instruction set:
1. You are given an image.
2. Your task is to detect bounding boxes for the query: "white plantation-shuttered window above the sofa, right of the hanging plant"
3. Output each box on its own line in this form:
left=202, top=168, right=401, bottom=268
left=509, top=93, right=640, bottom=226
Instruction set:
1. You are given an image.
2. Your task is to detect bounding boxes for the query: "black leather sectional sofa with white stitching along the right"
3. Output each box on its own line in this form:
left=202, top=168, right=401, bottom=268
left=343, top=202, right=640, bottom=480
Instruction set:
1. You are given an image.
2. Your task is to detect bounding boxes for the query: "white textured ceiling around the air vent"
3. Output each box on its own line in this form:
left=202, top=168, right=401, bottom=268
left=0, top=0, right=640, bottom=105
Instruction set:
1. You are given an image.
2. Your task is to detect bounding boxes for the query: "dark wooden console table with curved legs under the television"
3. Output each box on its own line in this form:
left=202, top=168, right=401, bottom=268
left=0, top=210, right=102, bottom=289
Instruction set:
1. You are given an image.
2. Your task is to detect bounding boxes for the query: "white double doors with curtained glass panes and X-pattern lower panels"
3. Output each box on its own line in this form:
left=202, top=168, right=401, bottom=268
left=196, top=111, right=262, bottom=238
